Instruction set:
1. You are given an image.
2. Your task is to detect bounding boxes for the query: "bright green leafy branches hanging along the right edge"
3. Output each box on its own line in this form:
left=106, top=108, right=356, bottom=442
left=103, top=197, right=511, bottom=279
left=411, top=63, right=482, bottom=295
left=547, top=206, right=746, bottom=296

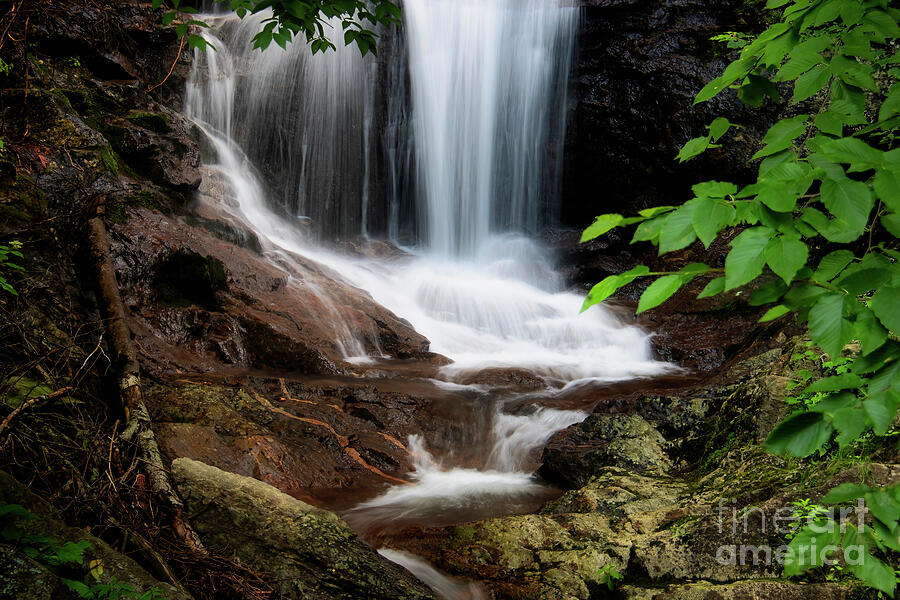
left=582, top=0, right=900, bottom=594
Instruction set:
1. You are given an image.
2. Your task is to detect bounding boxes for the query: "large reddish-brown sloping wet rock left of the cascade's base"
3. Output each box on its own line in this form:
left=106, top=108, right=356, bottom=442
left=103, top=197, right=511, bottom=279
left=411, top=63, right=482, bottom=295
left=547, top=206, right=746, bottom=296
left=112, top=208, right=432, bottom=373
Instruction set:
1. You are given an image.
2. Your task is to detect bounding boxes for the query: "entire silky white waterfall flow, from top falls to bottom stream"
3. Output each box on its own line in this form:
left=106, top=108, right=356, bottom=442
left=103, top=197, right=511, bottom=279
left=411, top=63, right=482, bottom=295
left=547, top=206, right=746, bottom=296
left=185, top=0, right=669, bottom=598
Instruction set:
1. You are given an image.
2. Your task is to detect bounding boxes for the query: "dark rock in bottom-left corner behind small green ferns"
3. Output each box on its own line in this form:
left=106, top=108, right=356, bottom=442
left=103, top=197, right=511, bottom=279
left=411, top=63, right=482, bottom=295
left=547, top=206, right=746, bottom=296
left=0, top=471, right=190, bottom=600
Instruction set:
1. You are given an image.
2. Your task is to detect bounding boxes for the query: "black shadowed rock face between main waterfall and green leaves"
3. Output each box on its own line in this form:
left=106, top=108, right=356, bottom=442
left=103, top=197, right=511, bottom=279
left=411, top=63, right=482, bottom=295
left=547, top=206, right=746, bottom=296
left=564, top=0, right=780, bottom=227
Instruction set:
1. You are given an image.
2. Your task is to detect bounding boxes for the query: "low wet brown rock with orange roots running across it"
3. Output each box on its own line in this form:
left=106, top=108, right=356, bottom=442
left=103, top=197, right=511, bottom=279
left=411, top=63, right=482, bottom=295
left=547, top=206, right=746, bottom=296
left=144, top=378, right=448, bottom=496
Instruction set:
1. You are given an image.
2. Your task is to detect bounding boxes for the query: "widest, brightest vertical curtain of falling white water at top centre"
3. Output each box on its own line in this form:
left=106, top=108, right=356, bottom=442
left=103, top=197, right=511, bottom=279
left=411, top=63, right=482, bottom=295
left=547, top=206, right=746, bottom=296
left=403, top=0, right=578, bottom=257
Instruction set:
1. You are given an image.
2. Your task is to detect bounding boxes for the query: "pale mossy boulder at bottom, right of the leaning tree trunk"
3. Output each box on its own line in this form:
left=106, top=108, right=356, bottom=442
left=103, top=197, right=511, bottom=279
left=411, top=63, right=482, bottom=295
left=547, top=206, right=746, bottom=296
left=172, top=458, right=434, bottom=600
